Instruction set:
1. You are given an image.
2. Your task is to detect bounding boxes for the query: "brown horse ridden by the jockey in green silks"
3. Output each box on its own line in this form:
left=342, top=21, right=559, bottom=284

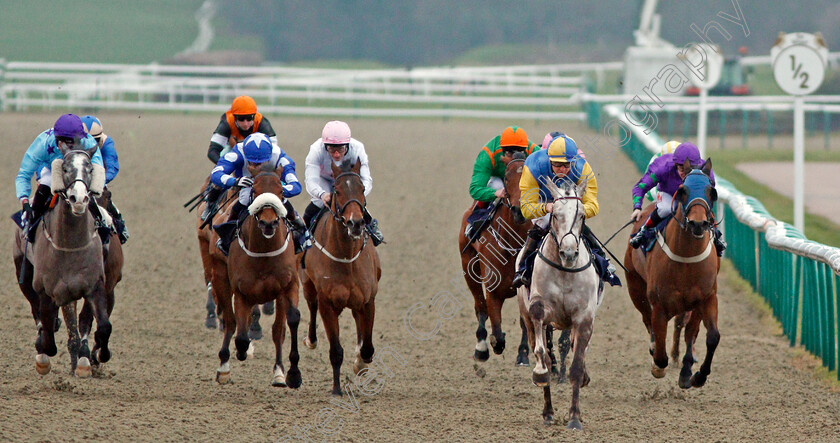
left=458, top=153, right=532, bottom=366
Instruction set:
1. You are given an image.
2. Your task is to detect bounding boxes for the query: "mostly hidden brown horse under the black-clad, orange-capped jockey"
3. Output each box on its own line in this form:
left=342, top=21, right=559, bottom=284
left=195, top=177, right=266, bottom=340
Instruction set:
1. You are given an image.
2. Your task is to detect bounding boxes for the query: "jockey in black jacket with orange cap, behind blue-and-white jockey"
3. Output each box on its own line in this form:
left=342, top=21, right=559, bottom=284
left=201, top=95, right=277, bottom=220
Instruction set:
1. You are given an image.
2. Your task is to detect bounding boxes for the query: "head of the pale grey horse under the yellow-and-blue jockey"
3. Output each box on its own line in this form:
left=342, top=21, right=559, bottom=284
left=546, top=180, right=586, bottom=267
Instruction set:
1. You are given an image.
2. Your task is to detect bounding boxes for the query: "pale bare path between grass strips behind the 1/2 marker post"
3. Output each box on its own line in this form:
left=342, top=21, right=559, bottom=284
left=736, top=162, right=840, bottom=224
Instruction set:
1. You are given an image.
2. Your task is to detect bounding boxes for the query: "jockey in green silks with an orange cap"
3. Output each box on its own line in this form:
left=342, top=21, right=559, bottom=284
left=464, top=126, right=540, bottom=239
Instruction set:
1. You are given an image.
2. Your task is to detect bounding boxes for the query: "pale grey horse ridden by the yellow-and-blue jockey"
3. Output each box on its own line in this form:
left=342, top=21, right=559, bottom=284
left=518, top=181, right=601, bottom=429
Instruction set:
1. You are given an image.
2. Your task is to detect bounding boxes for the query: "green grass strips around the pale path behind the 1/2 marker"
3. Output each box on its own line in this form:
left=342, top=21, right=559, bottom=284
left=712, top=150, right=840, bottom=247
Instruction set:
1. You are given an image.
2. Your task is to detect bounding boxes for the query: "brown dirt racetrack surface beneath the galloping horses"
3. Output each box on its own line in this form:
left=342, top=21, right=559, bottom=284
left=0, top=112, right=840, bottom=442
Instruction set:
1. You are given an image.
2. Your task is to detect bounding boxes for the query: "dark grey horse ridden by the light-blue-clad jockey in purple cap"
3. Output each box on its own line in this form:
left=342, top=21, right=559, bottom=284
left=13, top=148, right=110, bottom=377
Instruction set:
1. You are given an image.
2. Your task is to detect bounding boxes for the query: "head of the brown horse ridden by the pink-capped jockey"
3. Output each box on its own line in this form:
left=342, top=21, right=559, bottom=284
left=330, top=159, right=367, bottom=239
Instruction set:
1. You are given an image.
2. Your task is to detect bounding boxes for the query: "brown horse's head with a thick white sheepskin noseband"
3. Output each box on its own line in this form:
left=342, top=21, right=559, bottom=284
left=248, top=163, right=286, bottom=238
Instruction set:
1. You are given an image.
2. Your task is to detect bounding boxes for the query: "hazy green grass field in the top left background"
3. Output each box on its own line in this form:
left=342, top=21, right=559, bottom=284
left=0, top=0, right=261, bottom=63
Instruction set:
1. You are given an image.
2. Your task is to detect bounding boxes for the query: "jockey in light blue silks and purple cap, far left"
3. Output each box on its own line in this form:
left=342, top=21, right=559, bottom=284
left=15, top=114, right=110, bottom=244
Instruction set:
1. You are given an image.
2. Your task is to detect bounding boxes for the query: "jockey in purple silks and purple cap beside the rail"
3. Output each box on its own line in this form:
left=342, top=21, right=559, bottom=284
left=630, top=142, right=726, bottom=256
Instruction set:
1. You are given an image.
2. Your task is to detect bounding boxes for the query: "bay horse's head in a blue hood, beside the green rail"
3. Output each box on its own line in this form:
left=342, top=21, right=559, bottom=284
left=673, top=159, right=717, bottom=238
